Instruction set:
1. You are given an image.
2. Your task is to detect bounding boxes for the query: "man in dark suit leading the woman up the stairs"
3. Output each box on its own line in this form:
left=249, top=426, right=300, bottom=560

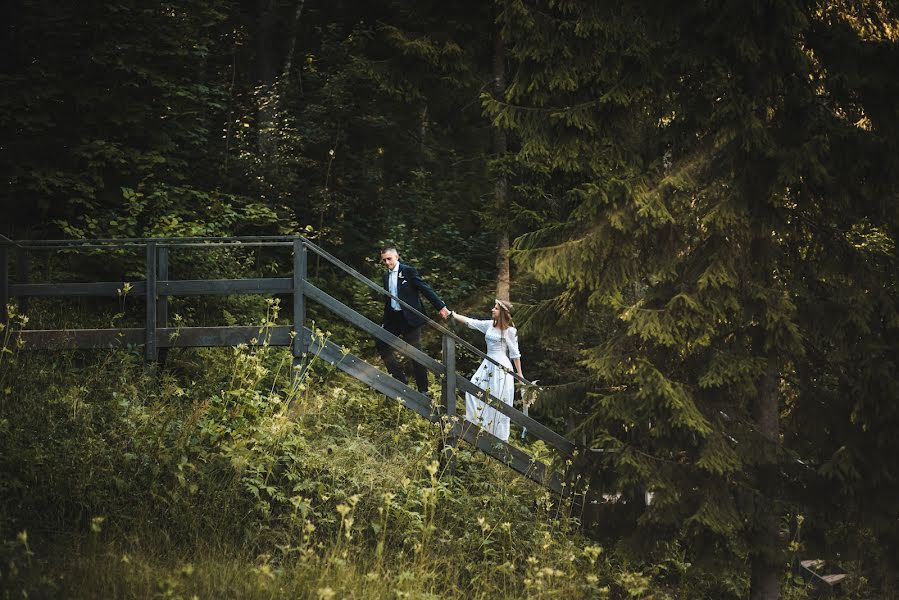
left=375, top=246, right=449, bottom=394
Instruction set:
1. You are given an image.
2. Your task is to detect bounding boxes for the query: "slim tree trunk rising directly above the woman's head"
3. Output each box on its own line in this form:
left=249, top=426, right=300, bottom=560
left=493, top=31, right=511, bottom=301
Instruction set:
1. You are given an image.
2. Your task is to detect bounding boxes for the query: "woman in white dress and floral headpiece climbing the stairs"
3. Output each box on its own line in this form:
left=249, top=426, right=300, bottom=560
left=450, top=300, right=524, bottom=441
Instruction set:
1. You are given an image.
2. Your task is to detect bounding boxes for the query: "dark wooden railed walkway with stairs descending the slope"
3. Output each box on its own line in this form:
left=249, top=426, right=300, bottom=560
left=0, top=236, right=596, bottom=504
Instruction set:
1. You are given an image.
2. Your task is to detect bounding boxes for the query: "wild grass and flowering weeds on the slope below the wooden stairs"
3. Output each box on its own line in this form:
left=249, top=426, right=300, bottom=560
left=0, top=304, right=816, bottom=599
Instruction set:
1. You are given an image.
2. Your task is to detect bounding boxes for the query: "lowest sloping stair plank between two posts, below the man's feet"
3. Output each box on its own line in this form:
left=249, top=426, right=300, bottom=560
left=303, top=328, right=438, bottom=422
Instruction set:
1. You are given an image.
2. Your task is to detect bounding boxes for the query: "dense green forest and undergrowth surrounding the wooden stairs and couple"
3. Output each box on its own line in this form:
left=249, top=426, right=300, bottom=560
left=0, top=0, right=899, bottom=600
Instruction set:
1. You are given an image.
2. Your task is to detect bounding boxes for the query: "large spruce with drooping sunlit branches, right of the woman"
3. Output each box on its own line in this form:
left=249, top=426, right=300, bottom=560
left=485, top=0, right=897, bottom=598
